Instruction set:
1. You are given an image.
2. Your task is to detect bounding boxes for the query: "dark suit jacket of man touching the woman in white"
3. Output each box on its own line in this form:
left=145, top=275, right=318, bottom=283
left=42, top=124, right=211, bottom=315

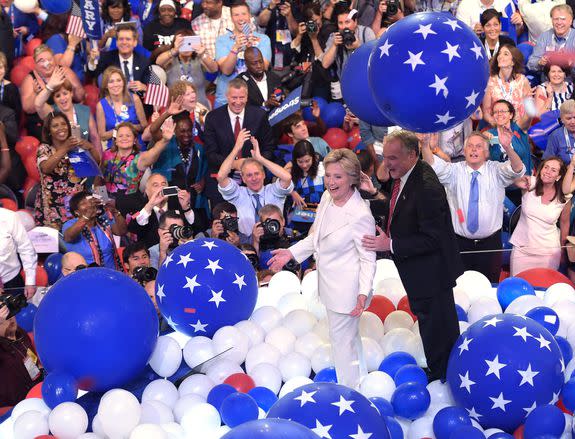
left=388, top=160, right=463, bottom=298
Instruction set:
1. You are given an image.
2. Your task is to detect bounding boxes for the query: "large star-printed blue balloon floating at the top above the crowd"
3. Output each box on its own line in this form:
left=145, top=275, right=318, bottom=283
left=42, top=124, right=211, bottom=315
left=369, top=12, right=489, bottom=133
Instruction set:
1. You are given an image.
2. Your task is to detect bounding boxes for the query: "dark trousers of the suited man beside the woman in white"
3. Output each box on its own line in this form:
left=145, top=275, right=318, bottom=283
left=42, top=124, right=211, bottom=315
left=408, top=288, right=459, bottom=379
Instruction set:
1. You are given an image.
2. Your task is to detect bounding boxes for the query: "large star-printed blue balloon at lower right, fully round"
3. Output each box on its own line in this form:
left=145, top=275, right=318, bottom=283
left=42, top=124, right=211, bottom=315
left=447, top=314, right=565, bottom=432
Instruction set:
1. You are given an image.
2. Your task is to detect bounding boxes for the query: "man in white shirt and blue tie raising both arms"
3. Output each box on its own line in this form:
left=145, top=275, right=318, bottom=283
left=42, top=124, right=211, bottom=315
left=421, top=130, right=525, bottom=283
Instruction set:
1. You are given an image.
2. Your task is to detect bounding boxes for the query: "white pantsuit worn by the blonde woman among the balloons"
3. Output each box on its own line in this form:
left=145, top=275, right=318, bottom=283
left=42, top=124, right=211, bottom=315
left=290, top=190, right=376, bottom=388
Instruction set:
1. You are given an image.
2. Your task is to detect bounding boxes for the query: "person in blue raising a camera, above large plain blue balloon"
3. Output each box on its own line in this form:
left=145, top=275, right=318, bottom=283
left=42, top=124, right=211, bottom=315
left=62, top=191, right=128, bottom=271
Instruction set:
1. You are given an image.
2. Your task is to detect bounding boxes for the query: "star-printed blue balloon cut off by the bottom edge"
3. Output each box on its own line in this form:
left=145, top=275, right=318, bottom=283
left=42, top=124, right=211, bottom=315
left=267, top=383, right=389, bottom=439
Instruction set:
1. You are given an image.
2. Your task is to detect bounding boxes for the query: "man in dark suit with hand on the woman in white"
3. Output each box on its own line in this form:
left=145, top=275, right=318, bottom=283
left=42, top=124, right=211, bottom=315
left=363, top=131, right=463, bottom=381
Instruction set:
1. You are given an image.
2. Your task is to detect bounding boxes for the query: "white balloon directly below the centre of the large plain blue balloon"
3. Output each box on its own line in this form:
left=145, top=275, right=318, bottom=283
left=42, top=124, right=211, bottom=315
left=98, top=389, right=142, bottom=438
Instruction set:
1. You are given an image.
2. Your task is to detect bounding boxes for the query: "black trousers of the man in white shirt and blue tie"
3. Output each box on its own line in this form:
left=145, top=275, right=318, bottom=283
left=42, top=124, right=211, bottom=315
left=456, top=230, right=503, bottom=283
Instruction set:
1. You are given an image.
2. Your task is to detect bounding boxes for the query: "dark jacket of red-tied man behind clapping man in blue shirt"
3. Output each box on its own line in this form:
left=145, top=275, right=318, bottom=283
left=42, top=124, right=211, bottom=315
left=204, top=105, right=274, bottom=174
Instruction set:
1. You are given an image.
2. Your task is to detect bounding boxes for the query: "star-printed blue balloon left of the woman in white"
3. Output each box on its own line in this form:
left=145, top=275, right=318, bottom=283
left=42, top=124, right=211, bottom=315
left=156, top=239, right=258, bottom=337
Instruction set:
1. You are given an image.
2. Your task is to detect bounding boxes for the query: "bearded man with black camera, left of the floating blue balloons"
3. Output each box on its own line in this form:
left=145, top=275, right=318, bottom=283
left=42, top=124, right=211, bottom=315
left=321, top=9, right=375, bottom=77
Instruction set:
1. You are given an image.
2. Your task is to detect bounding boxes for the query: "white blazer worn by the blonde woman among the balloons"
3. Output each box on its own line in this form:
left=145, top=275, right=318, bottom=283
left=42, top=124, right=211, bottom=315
left=289, top=190, right=376, bottom=314
